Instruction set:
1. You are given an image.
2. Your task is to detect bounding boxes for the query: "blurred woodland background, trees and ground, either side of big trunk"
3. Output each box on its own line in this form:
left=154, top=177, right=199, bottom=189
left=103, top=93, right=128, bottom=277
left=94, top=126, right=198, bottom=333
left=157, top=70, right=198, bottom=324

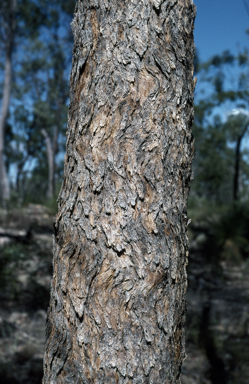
left=0, top=0, right=249, bottom=384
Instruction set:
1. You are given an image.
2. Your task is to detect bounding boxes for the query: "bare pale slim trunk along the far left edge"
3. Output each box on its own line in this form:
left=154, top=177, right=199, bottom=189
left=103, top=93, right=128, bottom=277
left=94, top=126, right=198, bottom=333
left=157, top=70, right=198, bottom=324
left=0, top=0, right=17, bottom=207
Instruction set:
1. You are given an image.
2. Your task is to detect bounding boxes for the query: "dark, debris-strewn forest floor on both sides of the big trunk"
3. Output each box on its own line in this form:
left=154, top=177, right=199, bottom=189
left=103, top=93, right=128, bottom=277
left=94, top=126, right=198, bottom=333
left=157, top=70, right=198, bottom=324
left=0, top=204, right=249, bottom=384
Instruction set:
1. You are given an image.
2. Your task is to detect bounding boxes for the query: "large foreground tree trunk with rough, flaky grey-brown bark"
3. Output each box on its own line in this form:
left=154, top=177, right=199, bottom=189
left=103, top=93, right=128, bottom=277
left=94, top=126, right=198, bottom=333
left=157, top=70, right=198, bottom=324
left=43, top=0, right=195, bottom=384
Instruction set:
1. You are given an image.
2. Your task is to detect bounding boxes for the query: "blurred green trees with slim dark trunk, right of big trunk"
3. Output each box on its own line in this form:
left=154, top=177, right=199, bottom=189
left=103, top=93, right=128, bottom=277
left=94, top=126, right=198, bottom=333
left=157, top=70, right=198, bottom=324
left=192, top=49, right=249, bottom=205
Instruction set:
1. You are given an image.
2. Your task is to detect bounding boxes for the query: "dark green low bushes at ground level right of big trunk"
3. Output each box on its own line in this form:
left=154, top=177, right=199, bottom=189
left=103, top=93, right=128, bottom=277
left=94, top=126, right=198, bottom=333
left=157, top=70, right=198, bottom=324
left=188, top=200, right=249, bottom=262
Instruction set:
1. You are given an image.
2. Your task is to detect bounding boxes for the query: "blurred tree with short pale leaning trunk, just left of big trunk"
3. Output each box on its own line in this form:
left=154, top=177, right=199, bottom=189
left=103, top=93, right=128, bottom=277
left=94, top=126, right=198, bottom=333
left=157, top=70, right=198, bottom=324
left=21, top=1, right=73, bottom=198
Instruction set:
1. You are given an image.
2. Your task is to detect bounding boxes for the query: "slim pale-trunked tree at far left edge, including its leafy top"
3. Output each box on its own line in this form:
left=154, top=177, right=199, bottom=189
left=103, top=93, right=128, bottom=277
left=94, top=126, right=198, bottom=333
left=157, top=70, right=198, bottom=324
left=0, top=0, right=48, bottom=206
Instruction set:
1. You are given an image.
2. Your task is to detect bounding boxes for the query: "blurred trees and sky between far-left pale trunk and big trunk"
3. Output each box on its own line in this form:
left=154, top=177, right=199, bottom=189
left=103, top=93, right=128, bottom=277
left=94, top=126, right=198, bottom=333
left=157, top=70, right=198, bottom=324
left=0, top=0, right=74, bottom=207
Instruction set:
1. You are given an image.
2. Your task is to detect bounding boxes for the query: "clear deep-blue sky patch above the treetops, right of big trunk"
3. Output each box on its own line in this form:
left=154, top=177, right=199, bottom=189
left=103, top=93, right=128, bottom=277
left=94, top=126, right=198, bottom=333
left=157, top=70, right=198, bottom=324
left=194, top=0, right=249, bottom=61
